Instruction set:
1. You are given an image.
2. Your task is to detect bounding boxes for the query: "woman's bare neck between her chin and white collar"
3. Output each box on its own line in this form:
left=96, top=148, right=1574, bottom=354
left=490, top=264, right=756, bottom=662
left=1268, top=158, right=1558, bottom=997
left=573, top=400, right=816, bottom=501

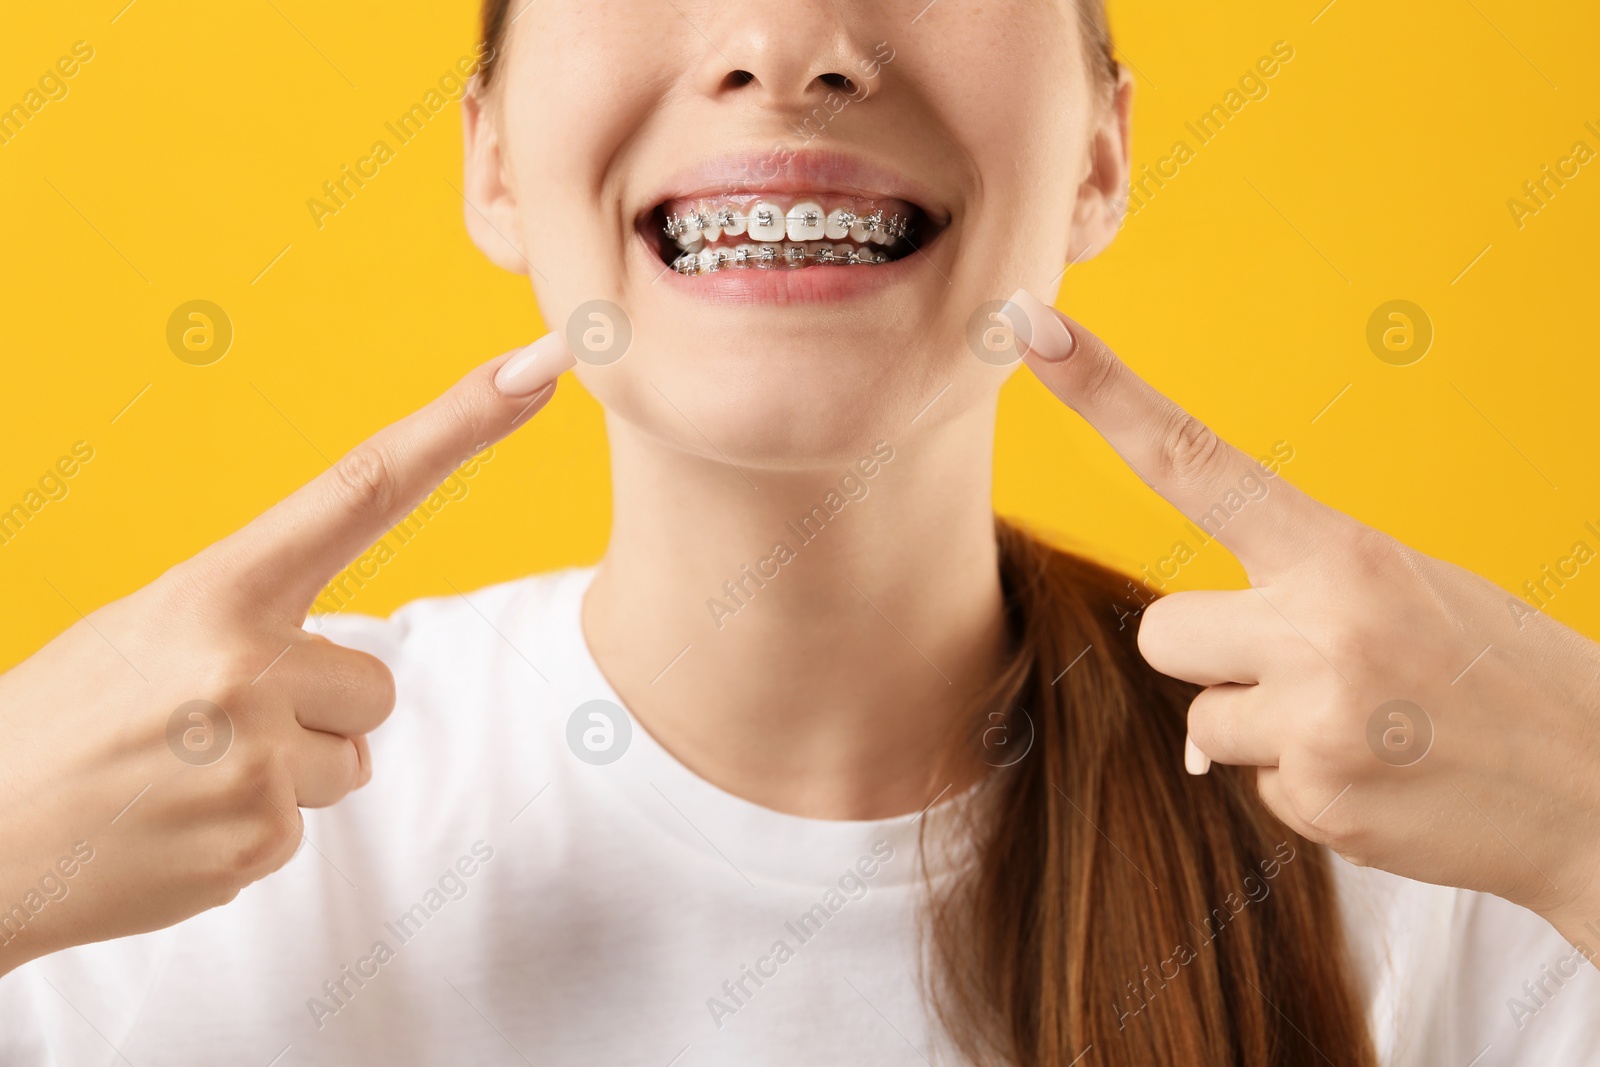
left=582, top=405, right=1006, bottom=819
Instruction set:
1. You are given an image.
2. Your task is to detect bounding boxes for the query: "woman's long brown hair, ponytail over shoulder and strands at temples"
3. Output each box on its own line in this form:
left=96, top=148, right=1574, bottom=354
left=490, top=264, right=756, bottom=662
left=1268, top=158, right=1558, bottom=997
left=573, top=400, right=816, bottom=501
left=480, top=0, right=1376, bottom=1067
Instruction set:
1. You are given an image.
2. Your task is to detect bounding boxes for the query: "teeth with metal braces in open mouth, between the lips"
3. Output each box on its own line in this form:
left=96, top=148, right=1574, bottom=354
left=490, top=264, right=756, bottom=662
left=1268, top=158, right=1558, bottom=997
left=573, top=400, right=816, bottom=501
left=645, top=194, right=936, bottom=275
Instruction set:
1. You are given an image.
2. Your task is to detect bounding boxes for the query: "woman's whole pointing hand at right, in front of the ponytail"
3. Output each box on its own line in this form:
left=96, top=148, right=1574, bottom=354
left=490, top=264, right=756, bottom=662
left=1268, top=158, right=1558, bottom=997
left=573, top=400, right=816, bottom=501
left=1011, top=293, right=1600, bottom=944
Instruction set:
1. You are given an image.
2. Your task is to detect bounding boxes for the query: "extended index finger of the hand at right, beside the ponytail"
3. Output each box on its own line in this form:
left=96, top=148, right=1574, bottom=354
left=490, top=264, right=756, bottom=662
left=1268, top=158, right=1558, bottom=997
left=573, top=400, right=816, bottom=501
left=1002, top=290, right=1336, bottom=576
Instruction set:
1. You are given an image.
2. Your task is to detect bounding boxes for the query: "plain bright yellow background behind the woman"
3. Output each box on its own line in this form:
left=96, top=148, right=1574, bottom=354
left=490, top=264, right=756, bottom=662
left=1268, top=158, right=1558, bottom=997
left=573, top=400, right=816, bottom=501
left=0, top=0, right=1600, bottom=665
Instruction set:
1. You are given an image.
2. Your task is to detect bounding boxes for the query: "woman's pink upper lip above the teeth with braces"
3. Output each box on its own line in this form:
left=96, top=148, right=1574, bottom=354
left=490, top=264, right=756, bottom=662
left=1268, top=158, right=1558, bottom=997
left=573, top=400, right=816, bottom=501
left=642, top=149, right=949, bottom=227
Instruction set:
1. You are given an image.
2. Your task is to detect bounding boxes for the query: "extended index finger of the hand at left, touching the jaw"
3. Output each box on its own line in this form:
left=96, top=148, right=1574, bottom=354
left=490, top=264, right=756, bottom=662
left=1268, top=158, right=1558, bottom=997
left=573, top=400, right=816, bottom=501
left=206, top=333, right=574, bottom=619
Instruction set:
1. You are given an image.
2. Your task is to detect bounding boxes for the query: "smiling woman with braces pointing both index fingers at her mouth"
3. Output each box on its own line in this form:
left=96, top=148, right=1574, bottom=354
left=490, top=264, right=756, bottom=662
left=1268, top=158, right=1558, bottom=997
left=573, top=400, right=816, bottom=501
left=0, top=0, right=1600, bottom=1065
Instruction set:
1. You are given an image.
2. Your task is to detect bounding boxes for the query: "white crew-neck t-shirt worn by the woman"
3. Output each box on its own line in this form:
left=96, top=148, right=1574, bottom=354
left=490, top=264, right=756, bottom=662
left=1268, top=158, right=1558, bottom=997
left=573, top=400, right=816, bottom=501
left=0, top=569, right=1600, bottom=1067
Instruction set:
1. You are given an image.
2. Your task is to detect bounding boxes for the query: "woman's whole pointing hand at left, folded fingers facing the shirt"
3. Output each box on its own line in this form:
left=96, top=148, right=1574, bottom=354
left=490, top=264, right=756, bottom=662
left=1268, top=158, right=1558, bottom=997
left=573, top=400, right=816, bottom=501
left=0, top=334, right=573, bottom=974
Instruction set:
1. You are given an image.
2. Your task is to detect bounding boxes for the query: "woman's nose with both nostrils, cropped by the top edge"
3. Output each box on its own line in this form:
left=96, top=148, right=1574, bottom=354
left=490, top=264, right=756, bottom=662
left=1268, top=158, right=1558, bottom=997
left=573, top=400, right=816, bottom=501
left=696, top=0, right=872, bottom=114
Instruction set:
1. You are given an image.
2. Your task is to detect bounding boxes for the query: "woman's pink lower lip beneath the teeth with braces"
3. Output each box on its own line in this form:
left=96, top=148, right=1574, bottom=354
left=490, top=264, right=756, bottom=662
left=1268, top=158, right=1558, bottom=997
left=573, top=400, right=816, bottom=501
left=638, top=238, right=938, bottom=306
